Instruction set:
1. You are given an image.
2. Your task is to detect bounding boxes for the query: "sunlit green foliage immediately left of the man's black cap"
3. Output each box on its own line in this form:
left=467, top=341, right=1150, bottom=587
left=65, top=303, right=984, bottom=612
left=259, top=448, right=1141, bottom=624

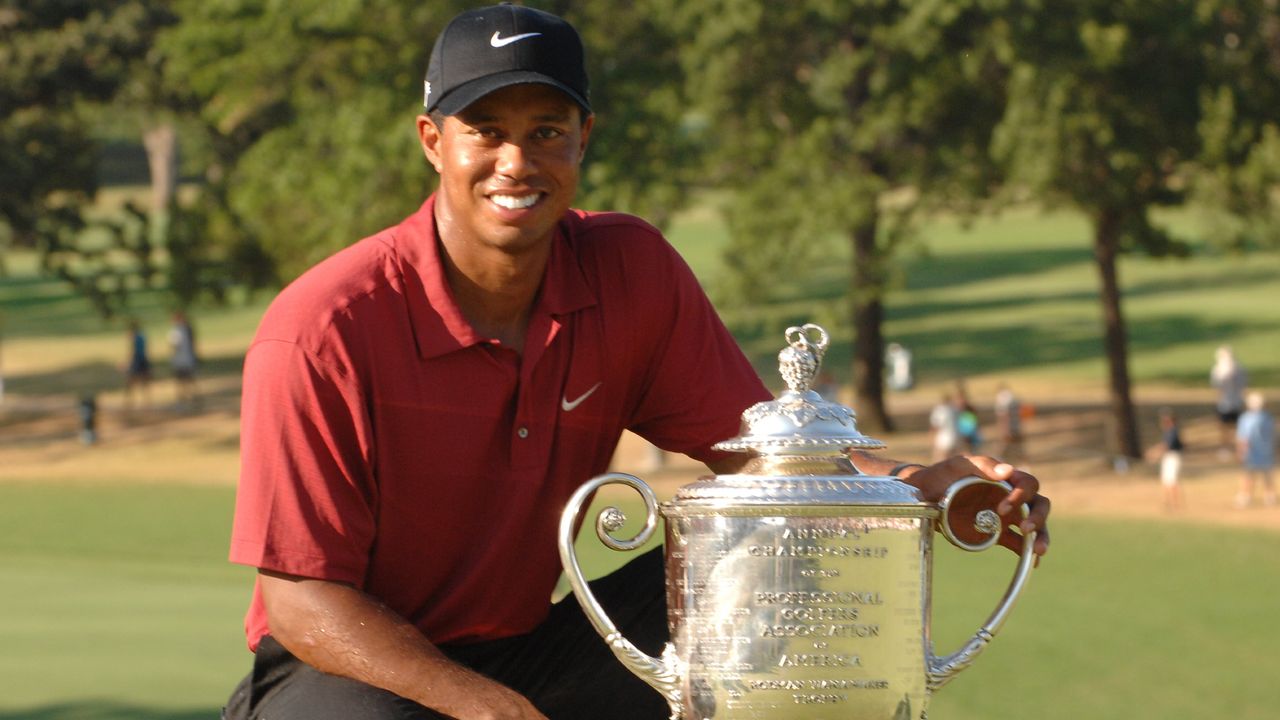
left=160, top=0, right=463, bottom=278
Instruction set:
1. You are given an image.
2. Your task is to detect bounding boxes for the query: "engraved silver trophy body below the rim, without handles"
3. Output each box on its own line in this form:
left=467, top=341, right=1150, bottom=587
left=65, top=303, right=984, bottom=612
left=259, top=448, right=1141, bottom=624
left=666, top=509, right=933, bottom=720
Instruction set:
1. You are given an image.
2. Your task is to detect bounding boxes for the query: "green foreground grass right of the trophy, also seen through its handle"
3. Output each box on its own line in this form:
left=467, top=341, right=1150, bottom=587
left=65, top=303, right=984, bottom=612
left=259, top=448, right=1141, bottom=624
left=931, top=519, right=1280, bottom=720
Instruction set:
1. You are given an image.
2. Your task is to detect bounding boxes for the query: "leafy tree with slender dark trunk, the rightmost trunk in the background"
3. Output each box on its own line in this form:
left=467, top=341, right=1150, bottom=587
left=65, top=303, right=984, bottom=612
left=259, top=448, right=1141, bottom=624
left=993, top=0, right=1215, bottom=457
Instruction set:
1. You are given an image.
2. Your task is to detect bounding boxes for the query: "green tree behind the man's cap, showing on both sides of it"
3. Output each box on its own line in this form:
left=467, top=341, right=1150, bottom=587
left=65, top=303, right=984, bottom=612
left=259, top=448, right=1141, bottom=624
left=161, top=0, right=706, bottom=288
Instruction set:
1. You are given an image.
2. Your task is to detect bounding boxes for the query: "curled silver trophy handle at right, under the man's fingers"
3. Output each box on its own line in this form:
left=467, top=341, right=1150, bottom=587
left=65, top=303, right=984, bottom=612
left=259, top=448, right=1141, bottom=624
left=928, top=478, right=1036, bottom=692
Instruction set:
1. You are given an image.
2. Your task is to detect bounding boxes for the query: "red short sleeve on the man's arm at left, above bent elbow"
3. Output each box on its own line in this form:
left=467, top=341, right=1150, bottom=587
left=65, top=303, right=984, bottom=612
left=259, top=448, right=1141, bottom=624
left=230, top=340, right=376, bottom=587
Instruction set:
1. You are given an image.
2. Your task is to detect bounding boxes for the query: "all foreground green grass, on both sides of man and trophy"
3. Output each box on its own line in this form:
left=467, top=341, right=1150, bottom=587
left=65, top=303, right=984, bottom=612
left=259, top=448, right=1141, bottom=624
left=0, top=483, right=1280, bottom=720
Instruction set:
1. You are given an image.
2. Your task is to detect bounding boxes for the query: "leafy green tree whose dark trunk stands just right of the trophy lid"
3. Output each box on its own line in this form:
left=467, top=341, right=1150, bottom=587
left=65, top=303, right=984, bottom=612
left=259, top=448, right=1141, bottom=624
left=659, top=0, right=1004, bottom=429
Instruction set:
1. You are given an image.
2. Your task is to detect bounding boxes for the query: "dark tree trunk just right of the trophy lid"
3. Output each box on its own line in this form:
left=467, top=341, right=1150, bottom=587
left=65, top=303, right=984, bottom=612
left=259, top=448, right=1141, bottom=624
left=850, top=214, right=893, bottom=433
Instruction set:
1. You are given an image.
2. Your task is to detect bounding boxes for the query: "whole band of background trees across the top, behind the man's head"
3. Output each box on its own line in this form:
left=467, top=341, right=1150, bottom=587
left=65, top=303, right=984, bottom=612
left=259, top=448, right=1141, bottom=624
left=0, top=0, right=1280, bottom=443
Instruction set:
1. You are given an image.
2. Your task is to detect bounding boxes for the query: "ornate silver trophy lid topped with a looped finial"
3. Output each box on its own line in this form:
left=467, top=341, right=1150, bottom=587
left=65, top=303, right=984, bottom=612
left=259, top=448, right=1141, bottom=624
left=713, top=324, right=884, bottom=457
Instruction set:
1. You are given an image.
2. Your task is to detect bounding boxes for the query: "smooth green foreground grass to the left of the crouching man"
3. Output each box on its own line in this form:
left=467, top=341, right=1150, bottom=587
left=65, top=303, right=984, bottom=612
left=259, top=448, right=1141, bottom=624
left=0, top=483, right=252, bottom=720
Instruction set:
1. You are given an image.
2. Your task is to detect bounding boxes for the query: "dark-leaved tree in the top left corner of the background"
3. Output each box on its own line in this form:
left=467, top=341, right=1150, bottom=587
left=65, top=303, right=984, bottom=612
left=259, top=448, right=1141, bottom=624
left=0, top=0, right=172, bottom=315
